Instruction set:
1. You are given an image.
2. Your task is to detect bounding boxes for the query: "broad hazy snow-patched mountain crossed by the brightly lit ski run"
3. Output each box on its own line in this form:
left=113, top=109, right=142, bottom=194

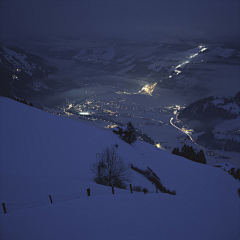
left=41, top=39, right=240, bottom=109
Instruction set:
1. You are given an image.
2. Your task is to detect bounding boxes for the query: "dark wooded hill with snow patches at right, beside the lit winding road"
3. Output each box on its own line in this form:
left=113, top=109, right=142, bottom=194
left=179, top=92, right=240, bottom=152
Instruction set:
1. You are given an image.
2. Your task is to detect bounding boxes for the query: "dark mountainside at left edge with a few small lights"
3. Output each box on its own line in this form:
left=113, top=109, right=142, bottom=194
left=0, top=46, right=76, bottom=104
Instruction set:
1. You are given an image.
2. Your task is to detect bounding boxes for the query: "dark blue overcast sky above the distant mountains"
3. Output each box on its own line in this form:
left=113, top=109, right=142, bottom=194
left=0, top=0, right=240, bottom=42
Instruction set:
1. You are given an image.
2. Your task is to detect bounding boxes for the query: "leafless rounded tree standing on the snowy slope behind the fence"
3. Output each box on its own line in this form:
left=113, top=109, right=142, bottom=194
left=91, top=146, right=131, bottom=188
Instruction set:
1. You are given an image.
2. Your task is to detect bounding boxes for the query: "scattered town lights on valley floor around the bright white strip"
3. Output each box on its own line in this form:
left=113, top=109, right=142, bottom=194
left=57, top=95, right=183, bottom=126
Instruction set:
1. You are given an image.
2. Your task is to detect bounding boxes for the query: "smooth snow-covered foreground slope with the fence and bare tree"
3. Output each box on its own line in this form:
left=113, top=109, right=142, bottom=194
left=0, top=97, right=240, bottom=240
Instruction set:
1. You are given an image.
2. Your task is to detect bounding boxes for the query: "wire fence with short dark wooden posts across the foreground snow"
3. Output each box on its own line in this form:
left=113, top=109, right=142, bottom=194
left=2, top=184, right=152, bottom=213
